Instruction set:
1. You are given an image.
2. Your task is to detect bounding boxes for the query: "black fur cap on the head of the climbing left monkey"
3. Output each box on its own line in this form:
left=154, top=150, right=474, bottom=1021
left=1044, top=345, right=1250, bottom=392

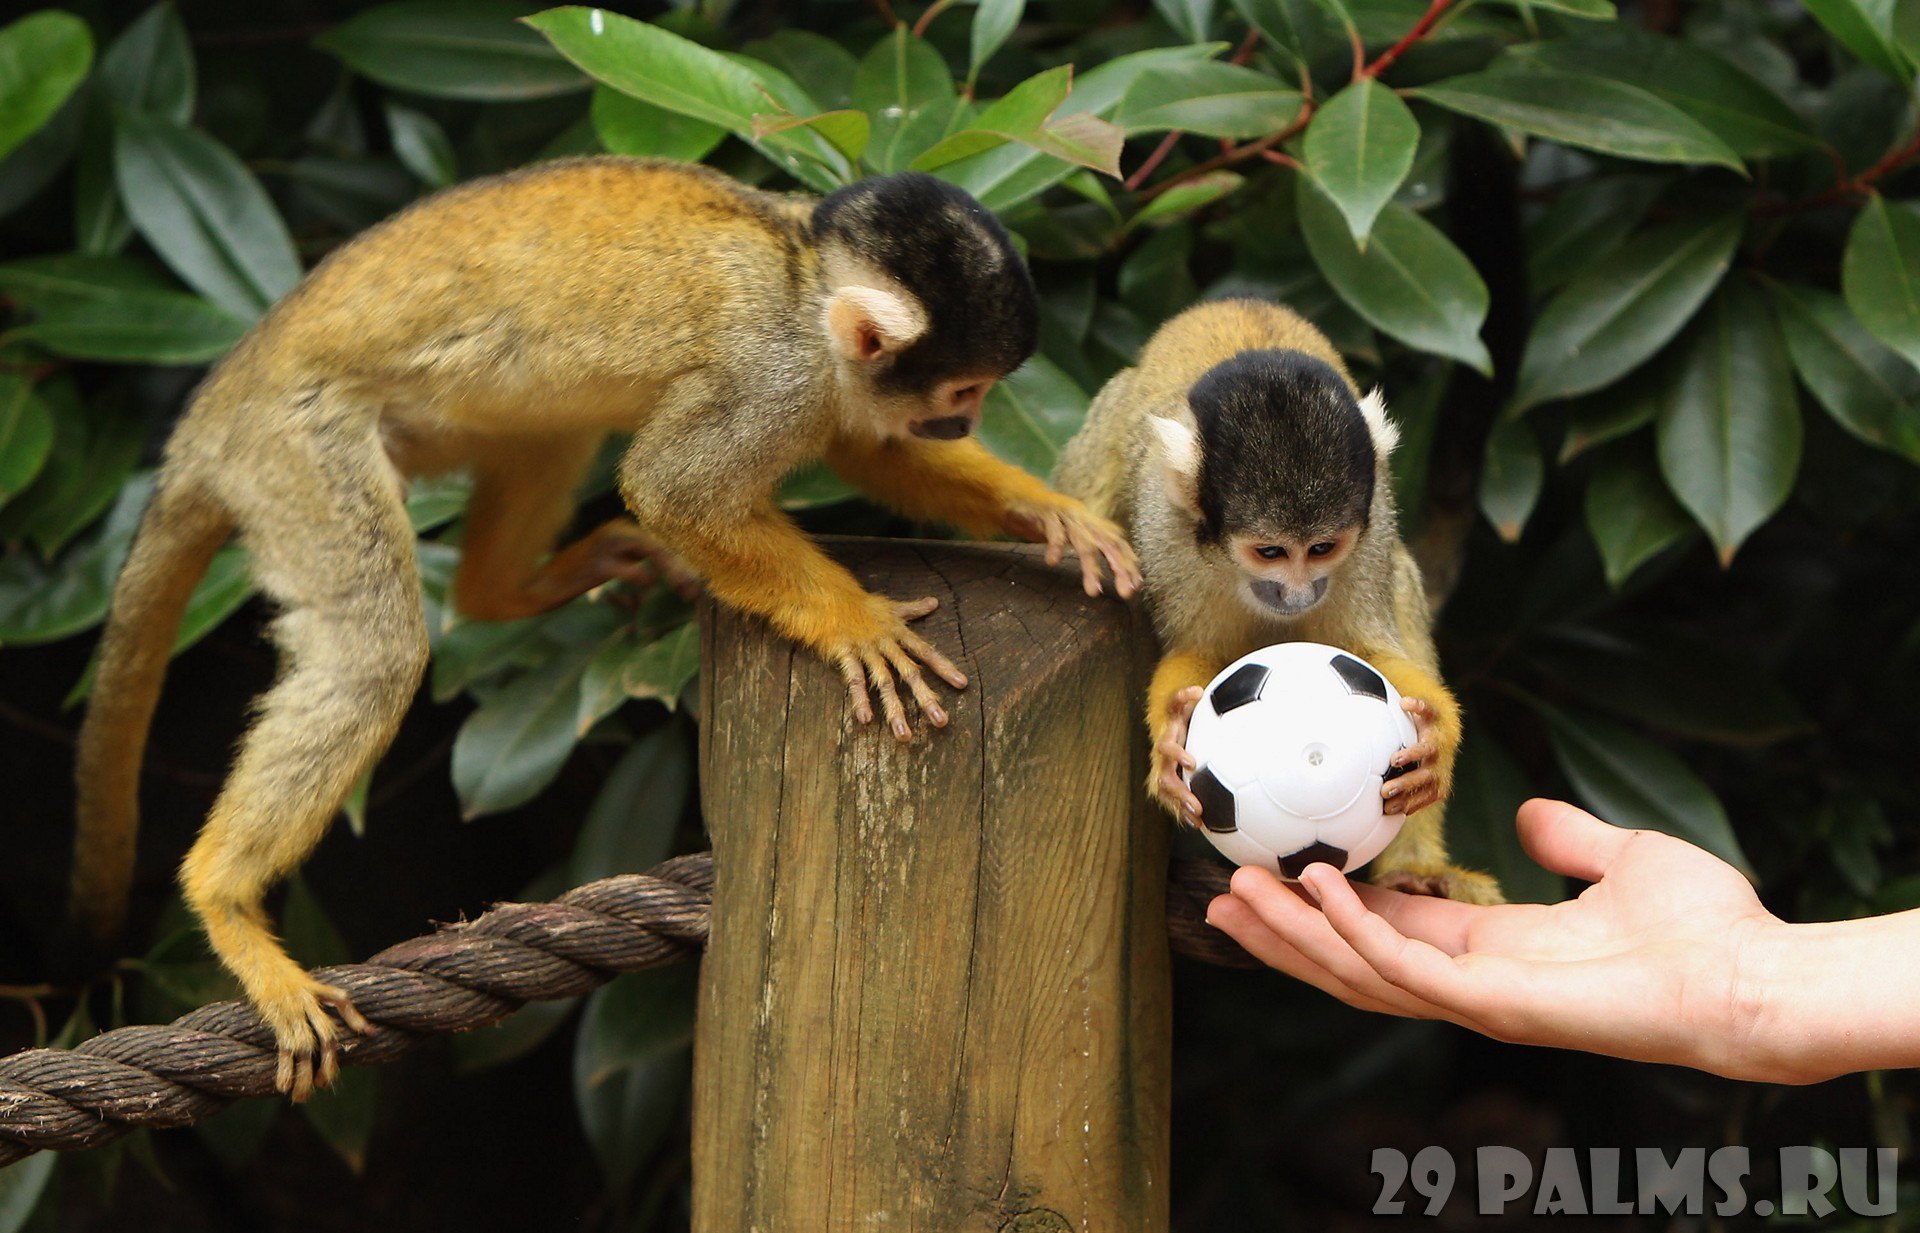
left=812, top=171, right=1041, bottom=392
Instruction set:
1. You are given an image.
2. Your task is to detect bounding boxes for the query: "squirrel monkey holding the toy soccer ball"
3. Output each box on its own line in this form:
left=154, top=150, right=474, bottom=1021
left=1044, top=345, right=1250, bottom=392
left=1054, top=300, right=1500, bottom=903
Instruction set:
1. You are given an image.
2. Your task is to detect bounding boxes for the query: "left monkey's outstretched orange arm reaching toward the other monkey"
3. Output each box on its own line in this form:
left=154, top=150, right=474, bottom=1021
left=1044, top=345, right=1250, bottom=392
left=826, top=436, right=1140, bottom=597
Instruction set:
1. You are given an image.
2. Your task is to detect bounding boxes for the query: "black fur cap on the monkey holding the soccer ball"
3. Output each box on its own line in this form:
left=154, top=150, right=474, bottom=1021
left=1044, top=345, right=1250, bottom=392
left=1187, top=350, right=1375, bottom=542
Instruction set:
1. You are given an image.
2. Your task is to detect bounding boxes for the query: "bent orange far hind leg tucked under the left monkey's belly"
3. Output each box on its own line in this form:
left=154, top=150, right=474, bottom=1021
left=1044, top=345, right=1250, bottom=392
left=453, top=436, right=699, bottom=620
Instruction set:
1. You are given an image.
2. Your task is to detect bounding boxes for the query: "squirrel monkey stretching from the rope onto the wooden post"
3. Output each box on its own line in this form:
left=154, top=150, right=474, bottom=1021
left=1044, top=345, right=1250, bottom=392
left=73, top=157, right=1139, bottom=1100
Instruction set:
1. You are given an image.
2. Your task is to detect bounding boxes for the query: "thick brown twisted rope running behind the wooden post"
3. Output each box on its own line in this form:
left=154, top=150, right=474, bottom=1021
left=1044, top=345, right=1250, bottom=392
left=0, top=853, right=1250, bottom=1168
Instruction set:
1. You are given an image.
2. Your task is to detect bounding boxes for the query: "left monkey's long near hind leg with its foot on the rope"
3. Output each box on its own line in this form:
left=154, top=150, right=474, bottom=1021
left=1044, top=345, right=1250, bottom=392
left=180, top=436, right=426, bottom=1100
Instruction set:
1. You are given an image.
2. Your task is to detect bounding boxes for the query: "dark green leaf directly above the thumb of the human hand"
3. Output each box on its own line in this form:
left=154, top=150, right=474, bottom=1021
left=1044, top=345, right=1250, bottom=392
left=1536, top=705, right=1753, bottom=878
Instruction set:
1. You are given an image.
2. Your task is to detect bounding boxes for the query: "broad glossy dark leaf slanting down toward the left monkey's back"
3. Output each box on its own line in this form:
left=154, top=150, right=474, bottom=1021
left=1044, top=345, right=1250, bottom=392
left=113, top=115, right=300, bottom=321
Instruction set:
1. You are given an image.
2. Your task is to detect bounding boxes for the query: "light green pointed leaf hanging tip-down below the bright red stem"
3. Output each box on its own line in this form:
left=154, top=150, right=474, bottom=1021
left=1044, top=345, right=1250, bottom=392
left=1302, top=77, right=1421, bottom=248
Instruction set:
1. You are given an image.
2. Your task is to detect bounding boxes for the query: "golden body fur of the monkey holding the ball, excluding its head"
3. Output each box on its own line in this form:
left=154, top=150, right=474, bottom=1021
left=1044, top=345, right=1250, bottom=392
left=1054, top=291, right=1500, bottom=903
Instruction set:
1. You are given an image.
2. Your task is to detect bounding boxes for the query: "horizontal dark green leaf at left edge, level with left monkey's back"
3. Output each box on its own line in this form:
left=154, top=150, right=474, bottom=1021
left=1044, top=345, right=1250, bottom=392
left=0, top=254, right=246, bottom=363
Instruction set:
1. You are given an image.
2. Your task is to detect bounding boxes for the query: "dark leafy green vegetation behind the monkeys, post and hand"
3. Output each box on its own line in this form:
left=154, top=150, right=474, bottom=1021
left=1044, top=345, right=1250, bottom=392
left=0, top=0, right=1920, bottom=1233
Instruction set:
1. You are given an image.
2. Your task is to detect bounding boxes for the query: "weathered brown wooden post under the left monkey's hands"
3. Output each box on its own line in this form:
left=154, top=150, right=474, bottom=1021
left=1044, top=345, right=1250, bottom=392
left=693, top=540, right=1169, bottom=1233
